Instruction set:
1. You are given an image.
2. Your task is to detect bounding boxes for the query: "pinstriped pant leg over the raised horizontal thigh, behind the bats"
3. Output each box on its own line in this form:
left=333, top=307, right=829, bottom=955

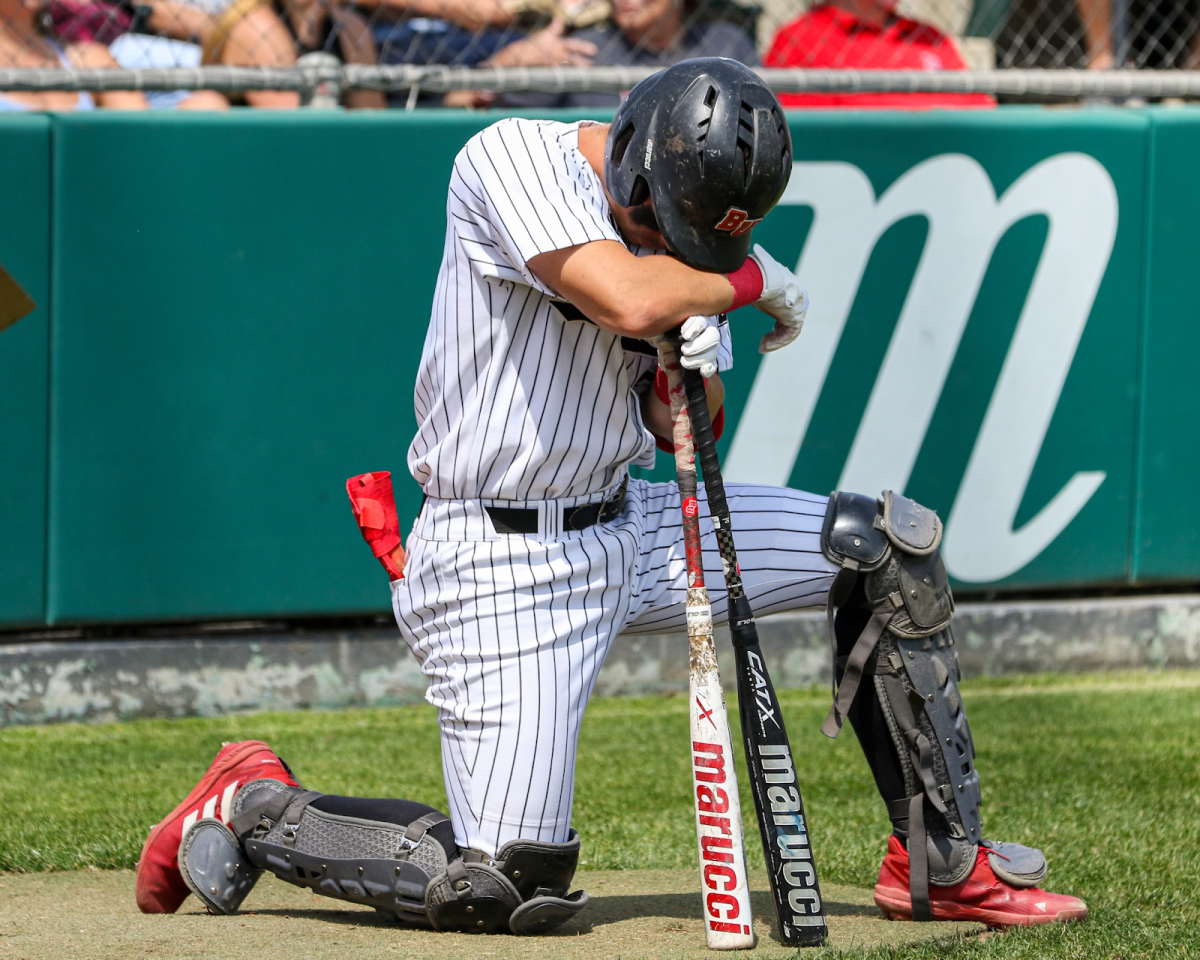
left=625, top=481, right=838, bottom=634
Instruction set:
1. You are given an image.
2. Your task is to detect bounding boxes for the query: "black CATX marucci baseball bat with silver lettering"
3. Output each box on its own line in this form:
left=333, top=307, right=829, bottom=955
left=673, top=337, right=828, bottom=947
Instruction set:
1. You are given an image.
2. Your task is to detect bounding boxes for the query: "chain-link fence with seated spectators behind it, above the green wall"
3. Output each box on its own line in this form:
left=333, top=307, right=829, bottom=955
left=0, top=0, right=1200, bottom=110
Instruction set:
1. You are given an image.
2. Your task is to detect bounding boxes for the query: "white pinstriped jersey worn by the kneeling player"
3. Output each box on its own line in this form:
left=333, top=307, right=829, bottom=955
left=408, top=118, right=732, bottom=503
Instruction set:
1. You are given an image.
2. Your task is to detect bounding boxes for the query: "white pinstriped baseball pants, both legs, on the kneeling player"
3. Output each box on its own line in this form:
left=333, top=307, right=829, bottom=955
left=392, top=480, right=836, bottom=856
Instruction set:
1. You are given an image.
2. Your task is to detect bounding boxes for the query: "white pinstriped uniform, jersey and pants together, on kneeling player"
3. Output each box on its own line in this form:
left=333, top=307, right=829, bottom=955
left=392, top=118, right=833, bottom=853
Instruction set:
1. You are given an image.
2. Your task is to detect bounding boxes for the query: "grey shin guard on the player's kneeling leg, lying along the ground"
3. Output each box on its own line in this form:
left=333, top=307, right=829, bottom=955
left=222, top=781, right=588, bottom=934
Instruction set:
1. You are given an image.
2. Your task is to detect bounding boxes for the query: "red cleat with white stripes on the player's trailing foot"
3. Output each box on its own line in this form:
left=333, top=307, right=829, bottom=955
left=137, top=740, right=299, bottom=913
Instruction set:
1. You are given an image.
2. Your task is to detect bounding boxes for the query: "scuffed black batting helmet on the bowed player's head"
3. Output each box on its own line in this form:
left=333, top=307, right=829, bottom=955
left=604, top=56, right=792, bottom=274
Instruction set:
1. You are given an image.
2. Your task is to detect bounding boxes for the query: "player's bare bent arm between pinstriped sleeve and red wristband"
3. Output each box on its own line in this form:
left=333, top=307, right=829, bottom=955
left=529, top=240, right=733, bottom=338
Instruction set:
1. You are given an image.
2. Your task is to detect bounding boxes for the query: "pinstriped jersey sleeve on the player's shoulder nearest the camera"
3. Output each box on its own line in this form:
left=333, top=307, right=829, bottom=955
left=450, top=118, right=622, bottom=296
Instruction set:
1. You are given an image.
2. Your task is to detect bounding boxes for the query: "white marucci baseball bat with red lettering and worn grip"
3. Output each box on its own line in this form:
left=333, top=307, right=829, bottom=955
left=659, top=337, right=755, bottom=950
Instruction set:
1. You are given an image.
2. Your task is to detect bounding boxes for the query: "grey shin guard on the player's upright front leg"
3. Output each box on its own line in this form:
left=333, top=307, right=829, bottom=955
left=822, top=491, right=988, bottom=919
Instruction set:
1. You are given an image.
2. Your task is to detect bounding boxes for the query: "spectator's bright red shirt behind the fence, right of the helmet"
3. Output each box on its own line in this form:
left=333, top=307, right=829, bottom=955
left=763, top=0, right=996, bottom=110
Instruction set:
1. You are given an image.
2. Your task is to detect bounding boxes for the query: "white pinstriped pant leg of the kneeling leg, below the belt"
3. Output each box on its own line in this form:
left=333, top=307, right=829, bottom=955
left=392, top=500, right=638, bottom=854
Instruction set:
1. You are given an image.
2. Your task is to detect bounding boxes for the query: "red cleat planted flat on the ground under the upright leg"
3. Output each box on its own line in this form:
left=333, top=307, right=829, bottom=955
left=875, top=835, right=1087, bottom=929
